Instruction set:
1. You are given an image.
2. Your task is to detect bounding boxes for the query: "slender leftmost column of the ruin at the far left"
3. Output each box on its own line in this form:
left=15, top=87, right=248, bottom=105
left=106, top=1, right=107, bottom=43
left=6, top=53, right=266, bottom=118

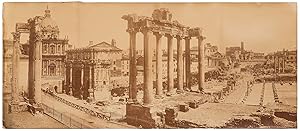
left=11, top=32, right=20, bottom=104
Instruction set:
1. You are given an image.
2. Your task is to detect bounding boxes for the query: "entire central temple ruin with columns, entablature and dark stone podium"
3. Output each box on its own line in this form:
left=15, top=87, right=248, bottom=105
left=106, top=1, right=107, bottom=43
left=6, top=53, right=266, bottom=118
left=122, top=8, right=205, bottom=127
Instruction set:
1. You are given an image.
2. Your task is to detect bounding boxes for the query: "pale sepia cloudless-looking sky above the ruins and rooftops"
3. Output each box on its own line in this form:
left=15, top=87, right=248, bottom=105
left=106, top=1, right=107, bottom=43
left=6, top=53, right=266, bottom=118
left=3, top=3, right=297, bottom=52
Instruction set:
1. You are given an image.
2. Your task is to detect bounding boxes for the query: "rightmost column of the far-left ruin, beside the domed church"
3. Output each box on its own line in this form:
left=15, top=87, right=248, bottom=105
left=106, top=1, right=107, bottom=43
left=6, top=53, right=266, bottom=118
left=34, top=32, right=42, bottom=104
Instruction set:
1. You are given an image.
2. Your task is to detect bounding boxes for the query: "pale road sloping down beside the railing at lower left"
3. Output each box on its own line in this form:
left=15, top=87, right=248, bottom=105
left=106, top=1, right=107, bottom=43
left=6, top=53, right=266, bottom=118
left=42, top=93, right=134, bottom=128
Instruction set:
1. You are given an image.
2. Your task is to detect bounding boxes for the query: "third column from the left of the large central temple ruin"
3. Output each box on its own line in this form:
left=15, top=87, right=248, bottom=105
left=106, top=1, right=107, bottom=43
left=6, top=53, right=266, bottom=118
left=154, top=32, right=163, bottom=98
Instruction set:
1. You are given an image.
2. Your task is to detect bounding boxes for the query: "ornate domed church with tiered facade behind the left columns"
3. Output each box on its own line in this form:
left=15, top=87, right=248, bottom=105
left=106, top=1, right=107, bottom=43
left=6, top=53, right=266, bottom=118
left=39, top=9, right=70, bottom=93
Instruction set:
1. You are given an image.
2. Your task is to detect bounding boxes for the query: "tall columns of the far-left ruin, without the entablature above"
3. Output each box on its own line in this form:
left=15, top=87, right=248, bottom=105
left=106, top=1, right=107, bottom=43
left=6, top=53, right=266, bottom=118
left=12, top=32, right=42, bottom=104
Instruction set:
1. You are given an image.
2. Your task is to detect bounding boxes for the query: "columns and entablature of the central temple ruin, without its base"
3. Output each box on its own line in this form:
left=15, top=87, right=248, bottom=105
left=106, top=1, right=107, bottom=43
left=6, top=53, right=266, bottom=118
left=122, top=8, right=205, bottom=105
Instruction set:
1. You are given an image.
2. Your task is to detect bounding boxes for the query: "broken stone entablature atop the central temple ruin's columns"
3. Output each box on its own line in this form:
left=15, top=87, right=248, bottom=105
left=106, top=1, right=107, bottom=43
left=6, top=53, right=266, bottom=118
left=122, top=8, right=202, bottom=38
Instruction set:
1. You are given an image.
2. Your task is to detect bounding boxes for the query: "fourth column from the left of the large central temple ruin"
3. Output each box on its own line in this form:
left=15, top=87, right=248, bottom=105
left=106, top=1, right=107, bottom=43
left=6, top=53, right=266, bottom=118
left=166, top=34, right=174, bottom=95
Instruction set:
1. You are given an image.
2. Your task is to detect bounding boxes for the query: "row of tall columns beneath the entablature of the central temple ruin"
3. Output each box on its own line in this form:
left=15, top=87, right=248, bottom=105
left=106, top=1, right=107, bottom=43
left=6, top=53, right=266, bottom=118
left=127, top=28, right=204, bottom=105
